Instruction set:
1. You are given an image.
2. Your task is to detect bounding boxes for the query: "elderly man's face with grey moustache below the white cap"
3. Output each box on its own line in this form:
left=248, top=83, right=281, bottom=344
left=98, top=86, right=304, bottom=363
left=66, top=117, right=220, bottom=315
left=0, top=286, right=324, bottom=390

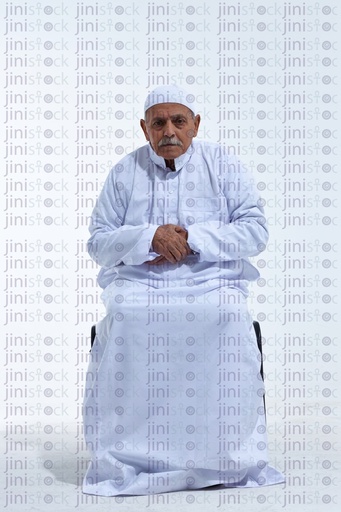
left=140, top=103, right=200, bottom=160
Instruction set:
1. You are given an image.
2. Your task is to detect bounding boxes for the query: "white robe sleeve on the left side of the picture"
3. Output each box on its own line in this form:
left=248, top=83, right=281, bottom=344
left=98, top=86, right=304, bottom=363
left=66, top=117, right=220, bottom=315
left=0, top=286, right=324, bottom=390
left=87, top=165, right=158, bottom=269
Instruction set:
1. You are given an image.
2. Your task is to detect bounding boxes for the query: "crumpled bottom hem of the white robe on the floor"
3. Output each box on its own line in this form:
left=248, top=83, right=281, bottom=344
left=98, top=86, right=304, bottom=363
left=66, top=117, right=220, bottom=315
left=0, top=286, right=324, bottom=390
left=82, top=463, right=285, bottom=497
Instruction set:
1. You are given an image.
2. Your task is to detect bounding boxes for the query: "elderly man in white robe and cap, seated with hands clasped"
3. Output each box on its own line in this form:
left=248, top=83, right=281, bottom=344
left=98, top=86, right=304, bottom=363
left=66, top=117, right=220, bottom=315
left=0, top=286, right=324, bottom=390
left=83, top=86, right=283, bottom=496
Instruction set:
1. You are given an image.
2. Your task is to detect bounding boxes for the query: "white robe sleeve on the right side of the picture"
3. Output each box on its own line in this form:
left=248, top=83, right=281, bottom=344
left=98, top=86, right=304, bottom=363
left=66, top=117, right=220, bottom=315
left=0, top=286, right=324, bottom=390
left=187, top=157, right=268, bottom=262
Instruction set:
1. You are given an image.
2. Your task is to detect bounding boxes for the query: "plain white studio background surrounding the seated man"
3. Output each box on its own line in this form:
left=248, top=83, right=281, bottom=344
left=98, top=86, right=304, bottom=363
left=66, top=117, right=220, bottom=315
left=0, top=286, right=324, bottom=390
left=1, top=0, right=340, bottom=512
